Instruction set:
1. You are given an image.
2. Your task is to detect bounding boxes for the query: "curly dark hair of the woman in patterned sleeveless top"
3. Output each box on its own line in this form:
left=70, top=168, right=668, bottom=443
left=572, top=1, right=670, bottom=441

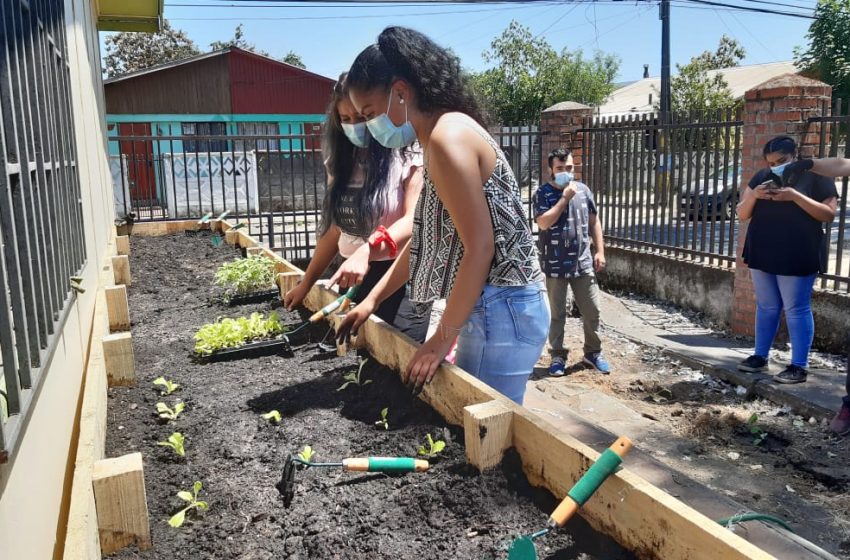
left=348, top=27, right=487, bottom=128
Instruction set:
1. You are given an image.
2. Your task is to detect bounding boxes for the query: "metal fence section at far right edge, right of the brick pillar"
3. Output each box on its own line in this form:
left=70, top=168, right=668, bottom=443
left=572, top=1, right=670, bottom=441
left=808, top=99, right=850, bottom=292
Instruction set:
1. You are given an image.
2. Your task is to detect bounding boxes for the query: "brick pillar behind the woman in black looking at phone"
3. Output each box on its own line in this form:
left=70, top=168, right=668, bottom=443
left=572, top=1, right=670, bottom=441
left=730, top=74, right=832, bottom=336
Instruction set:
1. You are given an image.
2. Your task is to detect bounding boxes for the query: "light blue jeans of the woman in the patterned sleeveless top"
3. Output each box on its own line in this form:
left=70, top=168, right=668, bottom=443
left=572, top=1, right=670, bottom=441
left=456, top=282, right=549, bottom=404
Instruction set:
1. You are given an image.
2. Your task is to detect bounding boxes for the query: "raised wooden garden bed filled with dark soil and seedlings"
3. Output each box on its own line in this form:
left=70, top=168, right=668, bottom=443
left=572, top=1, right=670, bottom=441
left=66, top=221, right=770, bottom=560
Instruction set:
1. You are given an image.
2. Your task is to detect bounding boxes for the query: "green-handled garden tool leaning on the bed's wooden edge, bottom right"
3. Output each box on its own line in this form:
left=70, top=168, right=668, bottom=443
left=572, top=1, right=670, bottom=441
left=508, top=436, right=632, bottom=560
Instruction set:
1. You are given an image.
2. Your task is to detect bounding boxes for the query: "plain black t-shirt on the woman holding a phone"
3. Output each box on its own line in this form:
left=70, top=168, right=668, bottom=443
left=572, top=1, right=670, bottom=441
left=743, top=169, right=838, bottom=276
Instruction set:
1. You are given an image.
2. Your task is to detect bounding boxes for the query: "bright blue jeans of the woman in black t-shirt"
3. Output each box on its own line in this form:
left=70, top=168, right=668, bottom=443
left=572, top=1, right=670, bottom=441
left=750, top=268, right=817, bottom=367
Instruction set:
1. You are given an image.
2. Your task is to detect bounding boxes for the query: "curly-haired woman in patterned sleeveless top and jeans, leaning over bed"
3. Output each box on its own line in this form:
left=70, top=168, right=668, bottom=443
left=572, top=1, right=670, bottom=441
left=338, top=27, right=549, bottom=404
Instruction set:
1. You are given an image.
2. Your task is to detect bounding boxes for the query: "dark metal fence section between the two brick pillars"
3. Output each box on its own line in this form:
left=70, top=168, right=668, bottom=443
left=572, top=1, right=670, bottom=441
left=580, top=111, right=743, bottom=267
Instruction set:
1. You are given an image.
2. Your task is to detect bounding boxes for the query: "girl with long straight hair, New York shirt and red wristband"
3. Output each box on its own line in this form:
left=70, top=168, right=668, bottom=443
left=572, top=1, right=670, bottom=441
left=283, top=74, right=430, bottom=342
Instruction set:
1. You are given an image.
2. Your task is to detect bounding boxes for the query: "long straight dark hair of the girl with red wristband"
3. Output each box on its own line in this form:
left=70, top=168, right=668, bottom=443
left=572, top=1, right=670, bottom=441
left=319, top=72, right=393, bottom=237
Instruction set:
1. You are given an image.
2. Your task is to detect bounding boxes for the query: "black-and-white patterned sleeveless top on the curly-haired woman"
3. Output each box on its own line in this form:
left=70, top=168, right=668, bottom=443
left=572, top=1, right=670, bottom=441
left=410, top=118, right=544, bottom=303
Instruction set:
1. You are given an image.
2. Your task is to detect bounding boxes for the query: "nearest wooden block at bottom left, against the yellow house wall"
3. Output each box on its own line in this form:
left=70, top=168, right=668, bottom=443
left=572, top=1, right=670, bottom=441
left=92, top=453, right=151, bottom=554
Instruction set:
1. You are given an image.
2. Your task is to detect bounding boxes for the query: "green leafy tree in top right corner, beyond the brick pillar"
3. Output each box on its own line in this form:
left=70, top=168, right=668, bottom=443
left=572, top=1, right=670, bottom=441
left=794, top=0, right=850, bottom=99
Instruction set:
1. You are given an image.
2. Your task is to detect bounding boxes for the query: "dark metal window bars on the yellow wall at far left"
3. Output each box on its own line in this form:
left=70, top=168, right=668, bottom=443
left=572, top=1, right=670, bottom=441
left=0, top=0, right=86, bottom=462
